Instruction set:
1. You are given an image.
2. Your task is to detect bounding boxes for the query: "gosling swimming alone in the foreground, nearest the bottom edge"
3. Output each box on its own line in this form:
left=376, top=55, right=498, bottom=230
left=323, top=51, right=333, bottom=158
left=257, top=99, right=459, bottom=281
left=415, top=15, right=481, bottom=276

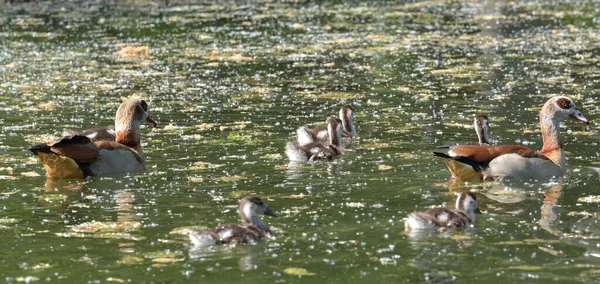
left=188, top=196, right=277, bottom=246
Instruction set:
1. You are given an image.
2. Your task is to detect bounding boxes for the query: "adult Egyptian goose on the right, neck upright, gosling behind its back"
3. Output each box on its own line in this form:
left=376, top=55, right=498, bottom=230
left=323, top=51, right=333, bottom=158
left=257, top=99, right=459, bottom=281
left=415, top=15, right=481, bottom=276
left=434, top=96, right=589, bottom=180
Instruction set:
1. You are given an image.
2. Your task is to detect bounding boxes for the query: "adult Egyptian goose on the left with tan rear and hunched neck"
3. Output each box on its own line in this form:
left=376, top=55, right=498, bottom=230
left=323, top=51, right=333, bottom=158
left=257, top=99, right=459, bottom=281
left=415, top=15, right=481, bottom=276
left=30, top=98, right=157, bottom=178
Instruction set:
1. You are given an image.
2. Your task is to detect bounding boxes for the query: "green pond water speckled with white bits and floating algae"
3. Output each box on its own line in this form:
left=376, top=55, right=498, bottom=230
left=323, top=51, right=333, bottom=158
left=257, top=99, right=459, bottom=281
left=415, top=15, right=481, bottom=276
left=0, top=0, right=600, bottom=283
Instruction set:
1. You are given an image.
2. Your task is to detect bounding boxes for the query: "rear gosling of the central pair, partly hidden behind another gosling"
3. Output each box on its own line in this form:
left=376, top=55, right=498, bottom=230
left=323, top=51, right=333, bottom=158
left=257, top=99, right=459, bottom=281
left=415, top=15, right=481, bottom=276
left=296, top=104, right=358, bottom=145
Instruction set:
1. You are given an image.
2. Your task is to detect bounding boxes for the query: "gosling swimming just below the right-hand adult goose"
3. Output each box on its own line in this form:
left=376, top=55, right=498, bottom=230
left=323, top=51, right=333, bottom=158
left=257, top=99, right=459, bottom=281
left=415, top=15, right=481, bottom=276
left=404, top=191, right=481, bottom=232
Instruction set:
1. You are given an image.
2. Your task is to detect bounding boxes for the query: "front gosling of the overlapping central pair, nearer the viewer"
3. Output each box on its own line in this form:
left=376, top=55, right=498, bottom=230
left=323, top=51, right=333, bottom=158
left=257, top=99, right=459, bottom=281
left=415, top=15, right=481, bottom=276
left=285, top=117, right=344, bottom=162
